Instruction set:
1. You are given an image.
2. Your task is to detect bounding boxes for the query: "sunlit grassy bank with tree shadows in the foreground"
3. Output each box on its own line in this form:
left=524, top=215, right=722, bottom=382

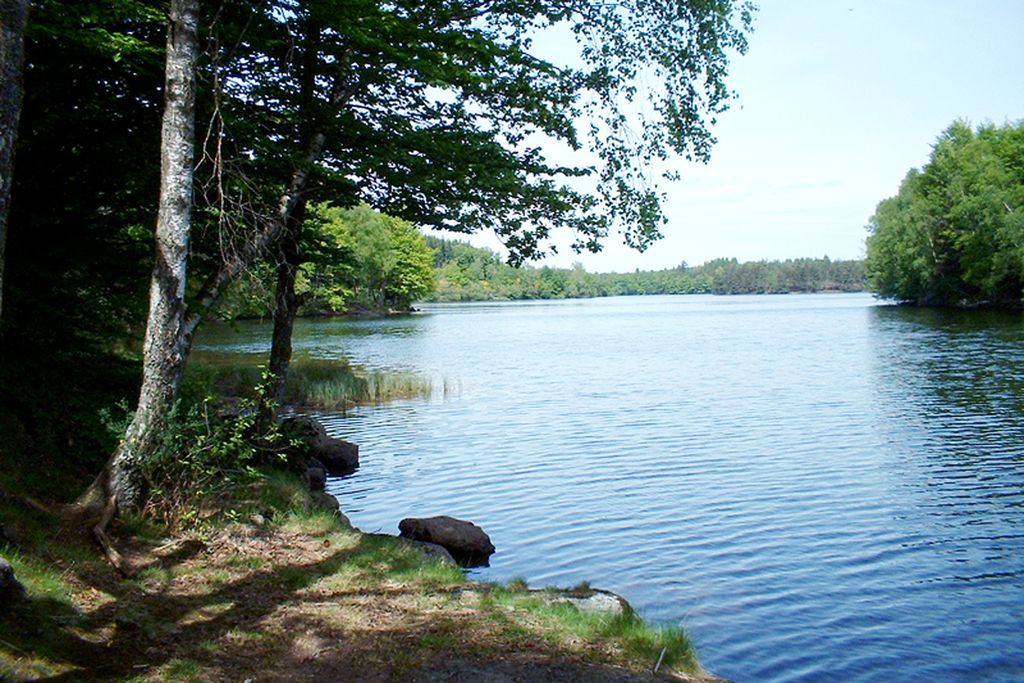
left=0, top=470, right=699, bottom=683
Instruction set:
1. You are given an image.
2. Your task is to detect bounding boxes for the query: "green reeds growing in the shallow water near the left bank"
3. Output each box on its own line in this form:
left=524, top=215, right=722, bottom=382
left=186, top=353, right=432, bottom=411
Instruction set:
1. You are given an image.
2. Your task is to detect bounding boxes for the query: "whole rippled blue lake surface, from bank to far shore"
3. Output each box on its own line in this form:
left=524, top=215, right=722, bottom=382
left=200, top=295, right=1024, bottom=682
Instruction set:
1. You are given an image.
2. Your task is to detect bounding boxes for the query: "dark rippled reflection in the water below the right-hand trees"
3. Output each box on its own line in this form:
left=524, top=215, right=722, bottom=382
left=871, top=307, right=1024, bottom=609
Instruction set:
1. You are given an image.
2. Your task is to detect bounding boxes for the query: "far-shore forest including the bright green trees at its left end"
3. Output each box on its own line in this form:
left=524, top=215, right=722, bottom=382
left=222, top=227, right=867, bottom=319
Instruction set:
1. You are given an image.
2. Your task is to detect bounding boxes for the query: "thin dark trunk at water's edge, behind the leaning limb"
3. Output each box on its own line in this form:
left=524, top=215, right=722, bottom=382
left=261, top=200, right=306, bottom=417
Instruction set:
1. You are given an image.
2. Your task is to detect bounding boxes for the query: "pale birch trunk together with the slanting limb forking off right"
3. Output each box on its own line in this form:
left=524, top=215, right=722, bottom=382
left=78, top=9, right=351, bottom=524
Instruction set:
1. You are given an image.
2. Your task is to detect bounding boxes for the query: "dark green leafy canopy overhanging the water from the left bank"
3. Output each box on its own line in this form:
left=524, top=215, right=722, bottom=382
left=197, top=0, right=753, bottom=261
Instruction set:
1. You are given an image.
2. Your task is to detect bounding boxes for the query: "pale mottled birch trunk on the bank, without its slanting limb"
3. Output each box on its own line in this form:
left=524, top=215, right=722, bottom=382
left=79, top=0, right=199, bottom=524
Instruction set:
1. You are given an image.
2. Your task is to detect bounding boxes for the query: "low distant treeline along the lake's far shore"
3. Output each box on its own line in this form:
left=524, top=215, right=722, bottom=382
left=426, top=237, right=866, bottom=301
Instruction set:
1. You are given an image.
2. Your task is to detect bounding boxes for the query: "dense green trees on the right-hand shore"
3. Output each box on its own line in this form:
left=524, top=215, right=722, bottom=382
left=867, top=121, right=1024, bottom=306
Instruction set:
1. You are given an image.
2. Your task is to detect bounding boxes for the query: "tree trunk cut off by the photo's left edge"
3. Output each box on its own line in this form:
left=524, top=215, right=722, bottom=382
left=0, top=0, right=29, bottom=323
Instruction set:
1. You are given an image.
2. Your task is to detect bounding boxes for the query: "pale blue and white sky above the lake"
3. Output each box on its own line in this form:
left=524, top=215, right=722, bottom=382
left=447, top=0, right=1024, bottom=272
